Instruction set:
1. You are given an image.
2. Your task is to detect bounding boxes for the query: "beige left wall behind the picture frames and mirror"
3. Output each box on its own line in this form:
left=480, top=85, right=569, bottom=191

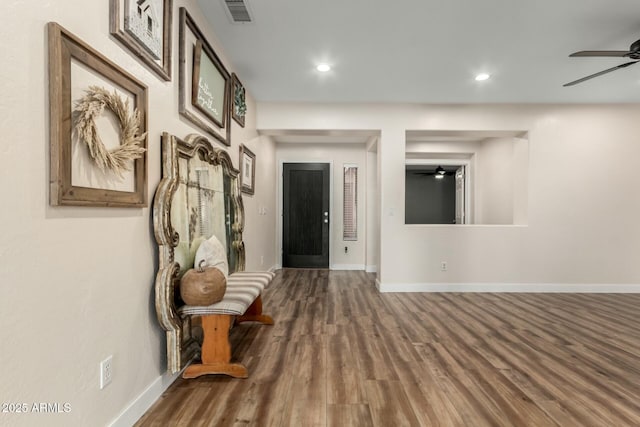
left=0, top=0, right=275, bottom=426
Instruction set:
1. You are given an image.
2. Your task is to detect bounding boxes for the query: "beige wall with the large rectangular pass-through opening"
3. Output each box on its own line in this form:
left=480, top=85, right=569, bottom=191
left=258, top=103, right=640, bottom=290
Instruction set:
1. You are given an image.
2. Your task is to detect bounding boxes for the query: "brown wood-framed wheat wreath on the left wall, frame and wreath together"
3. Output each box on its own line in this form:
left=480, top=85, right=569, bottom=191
left=47, top=22, right=148, bottom=207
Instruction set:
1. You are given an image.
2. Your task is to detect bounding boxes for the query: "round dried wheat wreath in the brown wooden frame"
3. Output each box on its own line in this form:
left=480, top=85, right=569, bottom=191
left=74, top=86, right=147, bottom=178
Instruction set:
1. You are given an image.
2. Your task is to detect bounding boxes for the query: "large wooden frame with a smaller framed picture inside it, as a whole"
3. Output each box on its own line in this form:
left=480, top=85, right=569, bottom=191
left=178, top=7, right=231, bottom=146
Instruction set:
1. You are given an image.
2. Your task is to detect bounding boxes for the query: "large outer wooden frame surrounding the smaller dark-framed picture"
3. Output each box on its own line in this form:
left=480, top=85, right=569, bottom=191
left=178, top=7, right=231, bottom=146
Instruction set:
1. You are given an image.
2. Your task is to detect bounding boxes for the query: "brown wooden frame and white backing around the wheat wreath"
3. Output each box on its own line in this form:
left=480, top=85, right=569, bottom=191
left=47, top=22, right=148, bottom=207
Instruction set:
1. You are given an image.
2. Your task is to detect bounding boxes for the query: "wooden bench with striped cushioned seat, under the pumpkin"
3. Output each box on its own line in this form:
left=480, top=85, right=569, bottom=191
left=178, top=271, right=275, bottom=378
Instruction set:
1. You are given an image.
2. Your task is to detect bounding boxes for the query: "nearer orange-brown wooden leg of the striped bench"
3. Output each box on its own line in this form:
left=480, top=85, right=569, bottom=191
left=182, top=314, right=249, bottom=378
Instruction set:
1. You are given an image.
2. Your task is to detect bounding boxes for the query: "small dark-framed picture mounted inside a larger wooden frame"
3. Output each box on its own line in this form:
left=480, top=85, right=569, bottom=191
left=191, top=40, right=227, bottom=127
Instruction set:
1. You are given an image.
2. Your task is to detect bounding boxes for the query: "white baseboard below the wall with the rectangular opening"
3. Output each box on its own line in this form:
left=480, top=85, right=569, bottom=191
left=376, top=280, right=640, bottom=294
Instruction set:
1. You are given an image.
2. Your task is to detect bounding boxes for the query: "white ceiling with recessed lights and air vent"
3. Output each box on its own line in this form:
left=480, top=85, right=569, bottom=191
left=198, top=0, right=640, bottom=103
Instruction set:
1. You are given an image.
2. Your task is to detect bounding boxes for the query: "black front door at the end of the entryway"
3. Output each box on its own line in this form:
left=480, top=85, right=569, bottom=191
left=282, top=163, right=329, bottom=268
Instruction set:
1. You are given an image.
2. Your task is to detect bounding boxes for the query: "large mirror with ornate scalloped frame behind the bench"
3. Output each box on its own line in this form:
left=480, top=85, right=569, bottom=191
left=153, top=133, right=245, bottom=373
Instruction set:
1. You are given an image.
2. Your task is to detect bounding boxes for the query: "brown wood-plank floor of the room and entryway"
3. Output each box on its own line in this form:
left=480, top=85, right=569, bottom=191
left=136, top=270, right=640, bottom=427
